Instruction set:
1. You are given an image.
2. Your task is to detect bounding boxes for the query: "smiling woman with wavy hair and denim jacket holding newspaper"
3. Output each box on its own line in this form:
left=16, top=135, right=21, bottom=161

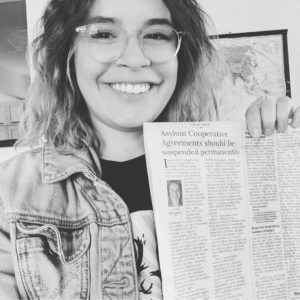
left=0, top=0, right=299, bottom=299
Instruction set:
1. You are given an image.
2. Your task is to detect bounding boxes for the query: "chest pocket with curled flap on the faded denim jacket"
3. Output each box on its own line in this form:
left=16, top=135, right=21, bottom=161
left=16, top=222, right=90, bottom=299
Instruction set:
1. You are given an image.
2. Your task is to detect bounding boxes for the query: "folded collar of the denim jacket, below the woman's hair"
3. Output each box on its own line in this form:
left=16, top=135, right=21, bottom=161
left=42, top=143, right=101, bottom=183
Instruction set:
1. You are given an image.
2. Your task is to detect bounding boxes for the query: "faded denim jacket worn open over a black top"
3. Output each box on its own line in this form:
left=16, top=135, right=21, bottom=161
left=0, top=144, right=138, bottom=300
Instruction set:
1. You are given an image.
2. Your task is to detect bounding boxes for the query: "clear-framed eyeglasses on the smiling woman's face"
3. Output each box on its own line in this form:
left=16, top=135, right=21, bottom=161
left=75, top=23, right=185, bottom=63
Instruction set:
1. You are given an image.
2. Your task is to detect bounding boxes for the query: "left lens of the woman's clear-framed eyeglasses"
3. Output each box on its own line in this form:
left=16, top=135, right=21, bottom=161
left=80, top=23, right=126, bottom=62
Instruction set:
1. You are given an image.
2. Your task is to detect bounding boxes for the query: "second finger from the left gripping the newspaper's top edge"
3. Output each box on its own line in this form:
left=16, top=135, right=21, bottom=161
left=261, top=97, right=276, bottom=136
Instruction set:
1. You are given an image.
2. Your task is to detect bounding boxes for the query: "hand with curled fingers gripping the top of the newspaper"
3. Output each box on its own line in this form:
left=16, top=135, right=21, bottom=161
left=246, top=96, right=300, bottom=138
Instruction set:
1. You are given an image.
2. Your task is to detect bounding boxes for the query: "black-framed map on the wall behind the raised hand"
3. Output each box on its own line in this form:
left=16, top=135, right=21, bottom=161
left=212, top=30, right=291, bottom=120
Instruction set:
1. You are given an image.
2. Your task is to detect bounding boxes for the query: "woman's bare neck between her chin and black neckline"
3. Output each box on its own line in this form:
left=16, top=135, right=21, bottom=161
left=97, top=125, right=145, bottom=161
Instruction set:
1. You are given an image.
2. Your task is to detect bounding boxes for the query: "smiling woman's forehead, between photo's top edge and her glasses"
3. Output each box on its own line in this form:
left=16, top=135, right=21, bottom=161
left=89, top=0, right=171, bottom=28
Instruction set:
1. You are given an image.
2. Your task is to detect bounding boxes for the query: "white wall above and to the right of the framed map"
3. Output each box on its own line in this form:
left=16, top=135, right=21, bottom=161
left=198, top=0, right=300, bottom=101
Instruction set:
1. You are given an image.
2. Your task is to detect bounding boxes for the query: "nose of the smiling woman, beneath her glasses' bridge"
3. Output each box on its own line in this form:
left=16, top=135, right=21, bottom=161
left=116, top=36, right=151, bottom=69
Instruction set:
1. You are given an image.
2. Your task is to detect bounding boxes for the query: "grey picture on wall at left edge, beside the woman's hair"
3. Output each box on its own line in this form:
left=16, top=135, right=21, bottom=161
left=0, top=0, right=30, bottom=147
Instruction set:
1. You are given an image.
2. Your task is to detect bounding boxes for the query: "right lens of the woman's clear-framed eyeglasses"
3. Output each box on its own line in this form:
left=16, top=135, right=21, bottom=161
left=141, top=25, right=179, bottom=63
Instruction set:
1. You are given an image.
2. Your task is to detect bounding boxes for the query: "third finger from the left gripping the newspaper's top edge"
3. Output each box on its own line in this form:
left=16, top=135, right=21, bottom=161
left=276, top=96, right=292, bottom=132
